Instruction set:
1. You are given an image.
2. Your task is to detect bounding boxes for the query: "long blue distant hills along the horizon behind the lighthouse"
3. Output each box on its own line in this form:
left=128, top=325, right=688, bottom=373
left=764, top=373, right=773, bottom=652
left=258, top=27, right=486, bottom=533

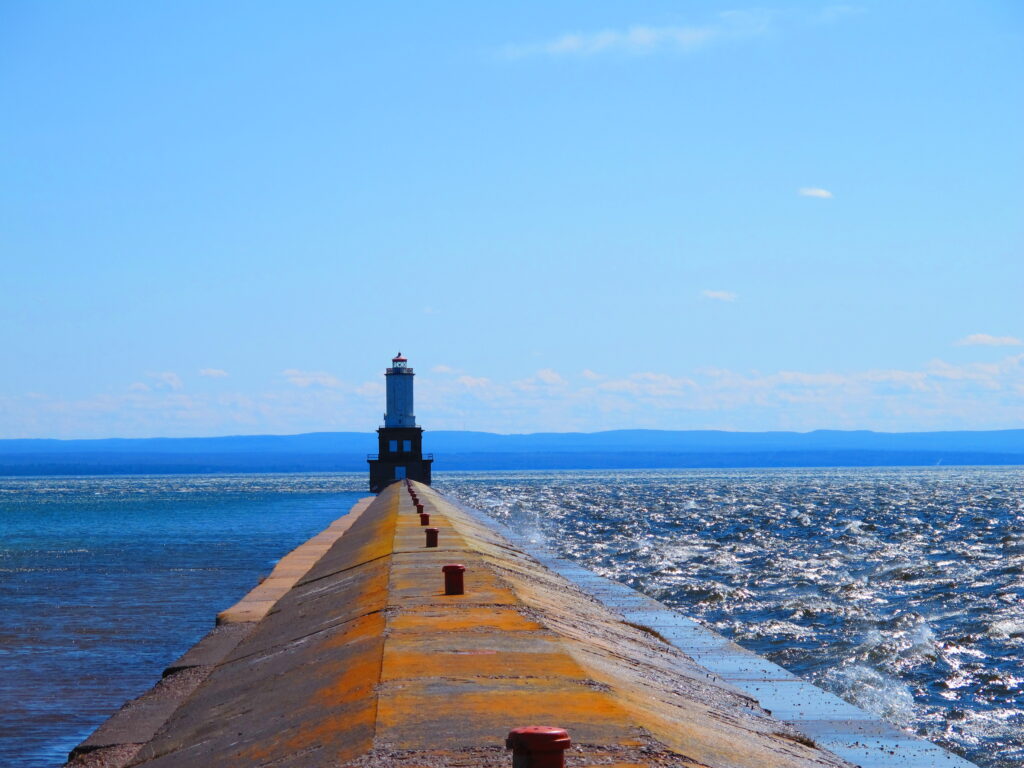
left=0, top=429, right=1024, bottom=475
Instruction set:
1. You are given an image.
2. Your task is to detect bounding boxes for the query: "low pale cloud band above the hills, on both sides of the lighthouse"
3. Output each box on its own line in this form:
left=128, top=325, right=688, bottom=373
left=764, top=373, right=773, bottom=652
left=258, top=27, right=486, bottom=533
left=0, top=353, right=1024, bottom=439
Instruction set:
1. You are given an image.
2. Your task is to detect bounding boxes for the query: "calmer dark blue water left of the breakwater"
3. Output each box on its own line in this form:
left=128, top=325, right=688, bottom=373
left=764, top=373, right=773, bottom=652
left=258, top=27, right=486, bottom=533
left=0, top=474, right=367, bottom=768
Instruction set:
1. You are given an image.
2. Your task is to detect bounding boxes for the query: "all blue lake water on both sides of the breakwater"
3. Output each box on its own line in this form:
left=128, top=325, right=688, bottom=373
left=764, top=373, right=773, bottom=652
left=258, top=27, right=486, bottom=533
left=0, top=468, right=1024, bottom=768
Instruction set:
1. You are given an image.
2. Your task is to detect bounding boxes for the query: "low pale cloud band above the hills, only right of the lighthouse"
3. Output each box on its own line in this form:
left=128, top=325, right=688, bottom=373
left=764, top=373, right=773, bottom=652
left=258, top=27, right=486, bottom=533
left=419, top=354, right=1024, bottom=432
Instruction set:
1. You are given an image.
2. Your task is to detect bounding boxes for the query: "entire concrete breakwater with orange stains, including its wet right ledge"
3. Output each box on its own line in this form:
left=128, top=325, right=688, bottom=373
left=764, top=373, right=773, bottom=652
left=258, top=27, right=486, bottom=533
left=69, top=483, right=970, bottom=768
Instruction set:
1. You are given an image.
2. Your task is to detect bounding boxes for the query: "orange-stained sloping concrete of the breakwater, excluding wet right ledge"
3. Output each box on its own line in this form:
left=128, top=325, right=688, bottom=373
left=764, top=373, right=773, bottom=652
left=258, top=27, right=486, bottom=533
left=79, top=483, right=843, bottom=768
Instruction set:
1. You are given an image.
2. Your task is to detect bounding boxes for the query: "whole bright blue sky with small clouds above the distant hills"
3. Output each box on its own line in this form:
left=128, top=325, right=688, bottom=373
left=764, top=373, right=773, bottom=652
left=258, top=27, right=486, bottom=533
left=0, top=0, right=1024, bottom=437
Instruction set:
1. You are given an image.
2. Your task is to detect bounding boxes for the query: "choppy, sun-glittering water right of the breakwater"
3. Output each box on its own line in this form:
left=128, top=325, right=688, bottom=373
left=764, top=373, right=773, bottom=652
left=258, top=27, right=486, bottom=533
left=435, top=468, right=1024, bottom=768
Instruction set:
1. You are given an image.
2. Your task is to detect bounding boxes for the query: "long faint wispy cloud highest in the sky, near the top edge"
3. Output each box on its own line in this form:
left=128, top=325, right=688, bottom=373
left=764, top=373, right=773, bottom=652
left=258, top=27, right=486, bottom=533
left=501, top=10, right=771, bottom=58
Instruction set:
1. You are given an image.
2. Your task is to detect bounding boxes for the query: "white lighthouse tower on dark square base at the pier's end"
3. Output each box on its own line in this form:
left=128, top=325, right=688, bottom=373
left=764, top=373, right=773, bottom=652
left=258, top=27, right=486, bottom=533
left=367, top=352, right=434, bottom=494
